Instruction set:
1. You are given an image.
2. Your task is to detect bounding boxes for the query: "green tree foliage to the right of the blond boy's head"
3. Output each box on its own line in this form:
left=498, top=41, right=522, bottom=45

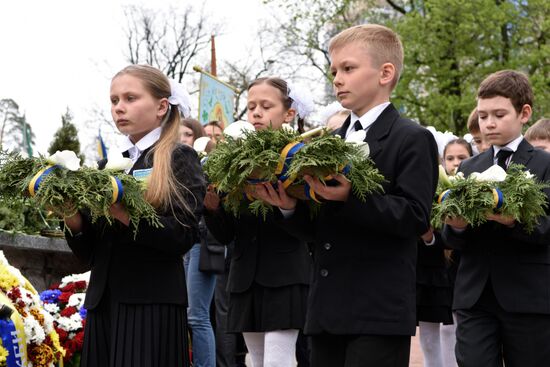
left=389, top=0, right=550, bottom=134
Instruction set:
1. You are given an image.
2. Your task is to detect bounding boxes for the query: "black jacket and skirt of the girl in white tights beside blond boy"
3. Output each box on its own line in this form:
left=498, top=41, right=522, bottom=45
left=204, top=208, right=311, bottom=332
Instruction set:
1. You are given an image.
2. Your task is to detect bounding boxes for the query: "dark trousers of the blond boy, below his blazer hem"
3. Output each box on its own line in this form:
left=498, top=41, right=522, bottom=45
left=311, top=334, right=411, bottom=367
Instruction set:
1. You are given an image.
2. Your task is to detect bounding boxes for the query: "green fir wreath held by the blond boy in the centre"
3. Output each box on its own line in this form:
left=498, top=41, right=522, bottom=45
left=203, top=128, right=384, bottom=218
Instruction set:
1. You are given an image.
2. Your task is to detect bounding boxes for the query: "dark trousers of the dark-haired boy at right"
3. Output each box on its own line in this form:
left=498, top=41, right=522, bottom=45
left=456, top=281, right=550, bottom=367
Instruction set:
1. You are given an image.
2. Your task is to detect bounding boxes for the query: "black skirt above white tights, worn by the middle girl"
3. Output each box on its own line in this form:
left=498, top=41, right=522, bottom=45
left=227, top=283, right=308, bottom=333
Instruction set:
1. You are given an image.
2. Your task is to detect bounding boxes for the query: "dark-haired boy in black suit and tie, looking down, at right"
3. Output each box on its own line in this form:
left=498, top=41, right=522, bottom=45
left=443, top=70, right=550, bottom=367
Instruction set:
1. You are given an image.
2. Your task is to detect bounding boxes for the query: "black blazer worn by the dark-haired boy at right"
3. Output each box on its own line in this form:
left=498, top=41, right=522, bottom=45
left=443, top=140, right=550, bottom=314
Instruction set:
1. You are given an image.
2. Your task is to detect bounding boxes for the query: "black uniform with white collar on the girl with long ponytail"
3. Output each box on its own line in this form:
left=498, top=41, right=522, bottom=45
left=66, top=130, right=205, bottom=367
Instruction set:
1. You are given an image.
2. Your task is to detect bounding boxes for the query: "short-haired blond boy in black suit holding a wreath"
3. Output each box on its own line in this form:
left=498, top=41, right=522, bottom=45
left=256, top=24, right=438, bottom=367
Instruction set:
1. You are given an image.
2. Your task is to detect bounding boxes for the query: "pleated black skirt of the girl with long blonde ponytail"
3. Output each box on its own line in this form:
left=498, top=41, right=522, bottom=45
left=80, top=292, right=190, bottom=367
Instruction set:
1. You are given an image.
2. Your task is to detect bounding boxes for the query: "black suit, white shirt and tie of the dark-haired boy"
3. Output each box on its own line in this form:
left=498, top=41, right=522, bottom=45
left=443, top=137, right=550, bottom=367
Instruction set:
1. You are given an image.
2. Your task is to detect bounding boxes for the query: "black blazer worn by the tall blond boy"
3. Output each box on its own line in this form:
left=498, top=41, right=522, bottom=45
left=284, top=105, right=438, bottom=335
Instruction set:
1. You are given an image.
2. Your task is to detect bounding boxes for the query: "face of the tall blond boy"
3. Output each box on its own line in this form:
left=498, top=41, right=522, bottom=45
left=330, top=42, right=389, bottom=116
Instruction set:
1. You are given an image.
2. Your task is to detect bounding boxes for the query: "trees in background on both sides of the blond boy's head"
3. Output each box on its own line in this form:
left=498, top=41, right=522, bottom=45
left=264, top=0, right=550, bottom=134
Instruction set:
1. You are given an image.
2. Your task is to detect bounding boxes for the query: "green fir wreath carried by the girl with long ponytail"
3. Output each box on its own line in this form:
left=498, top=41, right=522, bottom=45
left=0, top=153, right=162, bottom=234
